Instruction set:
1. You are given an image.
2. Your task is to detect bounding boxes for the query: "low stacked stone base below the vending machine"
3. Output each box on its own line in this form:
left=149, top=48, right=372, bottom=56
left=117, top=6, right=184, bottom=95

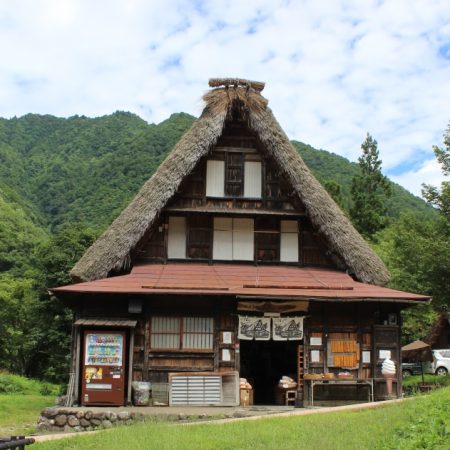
left=37, top=408, right=144, bottom=432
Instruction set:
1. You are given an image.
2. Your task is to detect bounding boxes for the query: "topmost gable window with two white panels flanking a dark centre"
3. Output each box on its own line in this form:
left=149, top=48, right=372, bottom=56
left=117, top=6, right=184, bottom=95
left=206, top=152, right=262, bottom=198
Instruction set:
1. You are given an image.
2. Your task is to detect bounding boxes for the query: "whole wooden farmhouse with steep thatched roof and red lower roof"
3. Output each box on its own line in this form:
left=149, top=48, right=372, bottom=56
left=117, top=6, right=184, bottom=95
left=52, top=79, right=430, bottom=405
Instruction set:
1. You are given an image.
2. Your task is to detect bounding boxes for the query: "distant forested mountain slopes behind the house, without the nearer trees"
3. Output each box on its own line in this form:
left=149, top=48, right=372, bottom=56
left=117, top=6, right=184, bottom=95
left=0, top=112, right=432, bottom=234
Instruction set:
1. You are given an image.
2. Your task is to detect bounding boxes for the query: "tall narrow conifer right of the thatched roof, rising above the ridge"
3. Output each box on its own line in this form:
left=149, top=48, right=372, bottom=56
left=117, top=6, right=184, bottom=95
left=350, top=133, right=391, bottom=238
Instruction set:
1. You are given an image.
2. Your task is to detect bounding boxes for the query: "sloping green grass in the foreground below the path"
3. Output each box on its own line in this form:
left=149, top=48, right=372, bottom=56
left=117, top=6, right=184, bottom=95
left=36, top=388, right=450, bottom=450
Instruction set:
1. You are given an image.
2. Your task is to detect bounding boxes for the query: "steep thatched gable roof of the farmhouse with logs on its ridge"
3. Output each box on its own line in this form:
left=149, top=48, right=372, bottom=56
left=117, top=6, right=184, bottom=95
left=71, top=79, right=389, bottom=285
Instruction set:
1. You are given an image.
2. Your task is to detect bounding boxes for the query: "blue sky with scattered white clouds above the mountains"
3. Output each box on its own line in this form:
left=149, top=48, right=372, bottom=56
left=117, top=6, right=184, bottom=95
left=0, top=0, right=450, bottom=195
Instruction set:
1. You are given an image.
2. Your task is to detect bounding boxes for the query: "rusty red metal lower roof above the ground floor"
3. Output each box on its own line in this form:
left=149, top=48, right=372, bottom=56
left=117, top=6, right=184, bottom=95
left=51, top=263, right=430, bottom=302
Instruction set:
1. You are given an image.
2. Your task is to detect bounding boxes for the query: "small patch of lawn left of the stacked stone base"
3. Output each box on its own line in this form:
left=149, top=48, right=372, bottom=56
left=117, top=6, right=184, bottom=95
left=0, top=394, right=55, bottom=436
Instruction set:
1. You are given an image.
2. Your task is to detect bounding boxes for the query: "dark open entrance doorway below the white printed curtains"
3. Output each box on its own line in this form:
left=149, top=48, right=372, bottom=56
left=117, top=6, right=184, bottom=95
left=240, top=341, right=299, bottom=405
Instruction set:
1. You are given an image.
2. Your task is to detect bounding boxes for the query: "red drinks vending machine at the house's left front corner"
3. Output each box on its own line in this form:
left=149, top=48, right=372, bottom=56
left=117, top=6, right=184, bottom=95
left=81, top=331, right=126, bottom=406
